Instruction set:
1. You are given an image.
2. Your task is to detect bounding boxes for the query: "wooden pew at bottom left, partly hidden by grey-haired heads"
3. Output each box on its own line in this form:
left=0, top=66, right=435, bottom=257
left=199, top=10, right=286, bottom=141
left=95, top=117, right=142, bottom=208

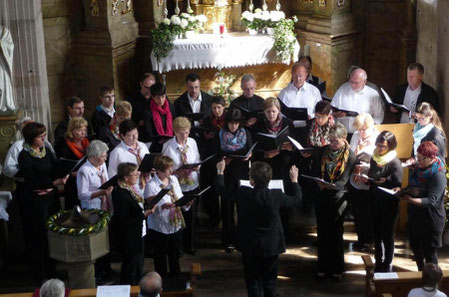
left=0, top=263, right=201, bottom=297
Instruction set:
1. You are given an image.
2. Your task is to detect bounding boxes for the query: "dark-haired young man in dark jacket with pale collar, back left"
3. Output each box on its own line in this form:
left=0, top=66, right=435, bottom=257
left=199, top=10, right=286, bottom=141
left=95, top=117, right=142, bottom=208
left=91, top=86, right=115, bottom=134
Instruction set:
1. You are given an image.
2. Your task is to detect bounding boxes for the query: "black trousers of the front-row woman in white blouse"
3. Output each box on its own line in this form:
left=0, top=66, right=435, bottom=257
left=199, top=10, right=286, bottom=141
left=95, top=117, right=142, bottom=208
left=149, top=229, right=181, bottom=277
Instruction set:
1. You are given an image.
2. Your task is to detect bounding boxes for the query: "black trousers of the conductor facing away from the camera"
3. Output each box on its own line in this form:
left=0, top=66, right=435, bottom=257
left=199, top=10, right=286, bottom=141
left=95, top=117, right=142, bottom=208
left=242, top=252, right=279, bottom=297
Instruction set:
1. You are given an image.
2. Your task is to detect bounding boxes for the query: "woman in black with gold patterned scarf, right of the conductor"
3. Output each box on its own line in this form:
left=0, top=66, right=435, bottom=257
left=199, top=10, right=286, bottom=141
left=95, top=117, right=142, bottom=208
left=312, top=123, right=355, bottom=281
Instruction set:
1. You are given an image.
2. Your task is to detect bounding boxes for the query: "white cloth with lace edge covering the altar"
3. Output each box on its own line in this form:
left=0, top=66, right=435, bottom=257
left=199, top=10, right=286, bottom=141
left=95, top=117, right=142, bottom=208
left=151, top=32, right=299, bottom=73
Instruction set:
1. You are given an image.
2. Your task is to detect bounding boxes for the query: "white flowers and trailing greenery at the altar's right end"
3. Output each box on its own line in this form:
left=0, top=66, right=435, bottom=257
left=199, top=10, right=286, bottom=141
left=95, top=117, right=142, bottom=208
left=274, top=16, right=298, bottom=61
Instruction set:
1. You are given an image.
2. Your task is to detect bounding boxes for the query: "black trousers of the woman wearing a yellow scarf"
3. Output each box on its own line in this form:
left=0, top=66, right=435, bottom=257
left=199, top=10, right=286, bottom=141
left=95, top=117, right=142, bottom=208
left=371, top=190, right=399, bottom=267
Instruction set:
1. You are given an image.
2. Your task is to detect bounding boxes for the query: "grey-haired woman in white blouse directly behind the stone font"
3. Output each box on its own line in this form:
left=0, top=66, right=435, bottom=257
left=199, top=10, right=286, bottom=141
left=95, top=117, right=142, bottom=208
left=76, top=140, right=113, bottom=212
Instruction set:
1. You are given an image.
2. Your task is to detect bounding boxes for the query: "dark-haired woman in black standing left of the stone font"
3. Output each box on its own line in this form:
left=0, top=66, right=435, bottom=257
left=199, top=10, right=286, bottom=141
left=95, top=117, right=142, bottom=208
left=18, top=122, right=68, bottom=283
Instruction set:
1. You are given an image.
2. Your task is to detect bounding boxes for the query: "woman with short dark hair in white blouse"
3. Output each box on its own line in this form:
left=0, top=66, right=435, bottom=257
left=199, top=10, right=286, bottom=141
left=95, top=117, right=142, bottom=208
left=108, top=120, right=149, bottom=182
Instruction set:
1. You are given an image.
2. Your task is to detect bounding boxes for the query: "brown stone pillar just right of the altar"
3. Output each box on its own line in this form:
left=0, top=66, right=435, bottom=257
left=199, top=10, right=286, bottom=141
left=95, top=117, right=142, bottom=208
left=300, top=0, right=358, bottom=96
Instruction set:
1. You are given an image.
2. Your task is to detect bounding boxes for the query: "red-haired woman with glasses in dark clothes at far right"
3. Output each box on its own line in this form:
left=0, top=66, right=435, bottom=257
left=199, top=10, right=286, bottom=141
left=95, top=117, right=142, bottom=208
left=402, top=141, right=446, bottom=270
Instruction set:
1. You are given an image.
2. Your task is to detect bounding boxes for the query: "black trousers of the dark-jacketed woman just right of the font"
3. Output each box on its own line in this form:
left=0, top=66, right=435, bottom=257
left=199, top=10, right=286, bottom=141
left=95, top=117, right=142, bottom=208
left=120, top=238, right=145, bottom=285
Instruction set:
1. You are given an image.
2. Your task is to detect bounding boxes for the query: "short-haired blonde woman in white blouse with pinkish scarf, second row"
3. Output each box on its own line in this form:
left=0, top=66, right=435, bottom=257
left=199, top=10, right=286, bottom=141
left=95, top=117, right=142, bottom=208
left=162, top=117, right=201, bottom=254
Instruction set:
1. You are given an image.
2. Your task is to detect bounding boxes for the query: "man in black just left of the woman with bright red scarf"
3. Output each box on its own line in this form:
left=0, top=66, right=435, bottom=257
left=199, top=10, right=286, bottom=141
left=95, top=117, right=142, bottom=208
left=126, top=73, right=156, bottom=141
